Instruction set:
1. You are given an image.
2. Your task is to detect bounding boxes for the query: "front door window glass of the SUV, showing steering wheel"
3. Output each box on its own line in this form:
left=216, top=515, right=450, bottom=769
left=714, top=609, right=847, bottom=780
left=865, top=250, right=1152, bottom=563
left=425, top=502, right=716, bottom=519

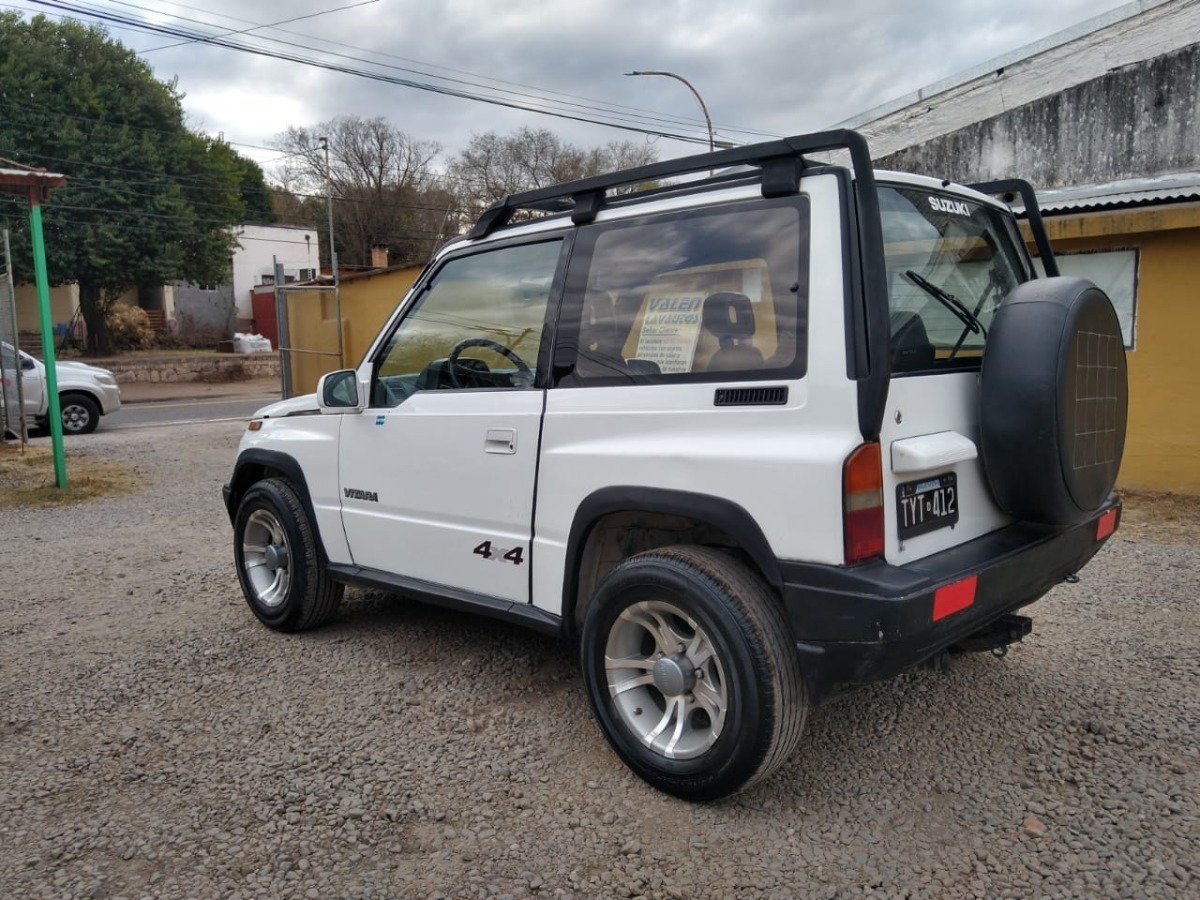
left=371, top=240, right=563, bottom=407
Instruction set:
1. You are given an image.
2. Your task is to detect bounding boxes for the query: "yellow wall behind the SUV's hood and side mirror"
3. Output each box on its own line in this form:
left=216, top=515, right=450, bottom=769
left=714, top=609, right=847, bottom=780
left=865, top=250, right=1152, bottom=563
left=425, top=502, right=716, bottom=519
left=288, top=265, right=421, bottom=395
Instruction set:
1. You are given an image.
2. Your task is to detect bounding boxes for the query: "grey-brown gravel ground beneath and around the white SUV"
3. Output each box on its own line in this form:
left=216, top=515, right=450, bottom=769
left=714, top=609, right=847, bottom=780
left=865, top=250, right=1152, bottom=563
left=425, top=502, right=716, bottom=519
left=0, top=424, right=1200, bottom=898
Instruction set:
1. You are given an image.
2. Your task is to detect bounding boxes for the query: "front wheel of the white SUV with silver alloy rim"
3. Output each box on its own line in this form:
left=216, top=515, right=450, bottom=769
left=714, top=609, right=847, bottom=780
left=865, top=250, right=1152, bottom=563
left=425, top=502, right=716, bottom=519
left=233, top=478, right=346, bottom=631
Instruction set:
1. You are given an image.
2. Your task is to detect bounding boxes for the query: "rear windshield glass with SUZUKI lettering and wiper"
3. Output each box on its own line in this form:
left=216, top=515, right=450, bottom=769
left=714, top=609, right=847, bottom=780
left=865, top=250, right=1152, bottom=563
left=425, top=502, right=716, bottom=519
left=880, top=186, right=1026, bottom=374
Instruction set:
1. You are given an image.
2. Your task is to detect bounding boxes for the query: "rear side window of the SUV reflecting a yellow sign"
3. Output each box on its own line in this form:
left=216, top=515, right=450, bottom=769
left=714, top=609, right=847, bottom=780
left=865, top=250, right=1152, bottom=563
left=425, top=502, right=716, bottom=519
left=556, top=197, right=809, bottom=386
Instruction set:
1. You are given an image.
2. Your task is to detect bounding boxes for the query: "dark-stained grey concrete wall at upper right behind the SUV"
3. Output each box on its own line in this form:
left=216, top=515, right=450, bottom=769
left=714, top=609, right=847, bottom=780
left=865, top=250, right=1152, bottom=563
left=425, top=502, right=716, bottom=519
left=876, top=43, right=1200, bottom=188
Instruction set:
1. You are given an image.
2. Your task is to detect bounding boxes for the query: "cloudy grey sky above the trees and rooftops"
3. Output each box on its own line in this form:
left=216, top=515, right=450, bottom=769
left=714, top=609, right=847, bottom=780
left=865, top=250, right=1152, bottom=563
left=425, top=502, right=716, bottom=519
left=7, top=0, right=1124, bottom=176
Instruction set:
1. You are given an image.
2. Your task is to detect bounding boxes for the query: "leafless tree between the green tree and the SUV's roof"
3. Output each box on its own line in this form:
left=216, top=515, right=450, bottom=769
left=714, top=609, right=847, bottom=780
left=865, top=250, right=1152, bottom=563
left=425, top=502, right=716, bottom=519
left=275, top=116, right=457, bottom=265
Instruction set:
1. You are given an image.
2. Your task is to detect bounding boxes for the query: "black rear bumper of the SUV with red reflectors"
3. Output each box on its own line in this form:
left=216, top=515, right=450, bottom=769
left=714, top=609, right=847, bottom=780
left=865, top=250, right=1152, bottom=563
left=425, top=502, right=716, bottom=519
left=780, top=497, right=1121, bottom=704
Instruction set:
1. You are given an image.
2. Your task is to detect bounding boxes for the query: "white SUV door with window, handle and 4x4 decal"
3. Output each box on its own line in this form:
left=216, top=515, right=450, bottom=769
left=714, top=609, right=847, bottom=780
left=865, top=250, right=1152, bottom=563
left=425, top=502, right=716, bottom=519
left=338, top=239, right=563, bottom=602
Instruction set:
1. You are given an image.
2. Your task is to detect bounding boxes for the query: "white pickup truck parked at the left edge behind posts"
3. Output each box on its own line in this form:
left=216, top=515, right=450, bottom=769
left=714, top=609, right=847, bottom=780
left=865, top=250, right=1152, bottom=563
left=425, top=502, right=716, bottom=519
left=0, top=343, right=121, bottom=434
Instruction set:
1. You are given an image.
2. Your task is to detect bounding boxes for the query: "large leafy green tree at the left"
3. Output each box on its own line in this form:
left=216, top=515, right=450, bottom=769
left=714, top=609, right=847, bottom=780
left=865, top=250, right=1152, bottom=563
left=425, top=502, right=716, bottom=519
left=0, top=13, right=275, bottom=354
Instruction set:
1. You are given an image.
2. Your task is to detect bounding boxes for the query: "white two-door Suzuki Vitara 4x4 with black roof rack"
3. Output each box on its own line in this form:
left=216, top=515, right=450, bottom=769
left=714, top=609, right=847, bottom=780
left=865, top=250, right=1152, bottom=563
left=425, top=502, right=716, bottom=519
left=226, top=131, right=1127, bottom=799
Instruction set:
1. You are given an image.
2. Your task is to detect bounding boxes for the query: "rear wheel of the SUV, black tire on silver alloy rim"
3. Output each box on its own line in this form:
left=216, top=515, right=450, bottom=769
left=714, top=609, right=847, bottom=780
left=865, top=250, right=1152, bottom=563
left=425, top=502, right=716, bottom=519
left=581, top=546, right=808, bottom=800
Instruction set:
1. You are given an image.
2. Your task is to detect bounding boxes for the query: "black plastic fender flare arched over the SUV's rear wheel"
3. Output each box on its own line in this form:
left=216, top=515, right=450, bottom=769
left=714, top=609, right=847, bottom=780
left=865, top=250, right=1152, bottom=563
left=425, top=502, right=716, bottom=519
left=563, top=485, right=782, bottom=629
